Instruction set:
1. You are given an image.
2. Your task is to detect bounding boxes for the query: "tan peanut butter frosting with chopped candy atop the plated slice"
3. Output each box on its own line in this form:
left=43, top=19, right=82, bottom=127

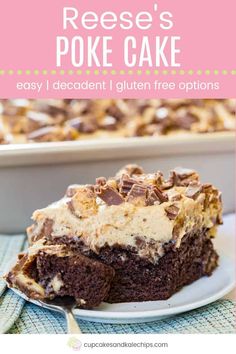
left=27, top=165, right=222, bottom=262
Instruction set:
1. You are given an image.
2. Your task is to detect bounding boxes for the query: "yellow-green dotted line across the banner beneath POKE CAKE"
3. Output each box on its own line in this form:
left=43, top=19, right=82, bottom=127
left=0, top=69, right=236, bottom=76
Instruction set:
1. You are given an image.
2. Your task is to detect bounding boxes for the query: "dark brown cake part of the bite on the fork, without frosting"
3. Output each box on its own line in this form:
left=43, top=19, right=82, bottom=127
left=37, top=252, right=115, bottom=308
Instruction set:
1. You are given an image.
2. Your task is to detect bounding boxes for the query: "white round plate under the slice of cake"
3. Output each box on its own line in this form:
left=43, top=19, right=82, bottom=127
left=14, top=214, right=235, bottom=323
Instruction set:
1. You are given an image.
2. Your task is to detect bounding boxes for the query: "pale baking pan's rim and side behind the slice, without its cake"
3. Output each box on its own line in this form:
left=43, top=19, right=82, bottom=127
left=0, top=132, right=235, bottom=233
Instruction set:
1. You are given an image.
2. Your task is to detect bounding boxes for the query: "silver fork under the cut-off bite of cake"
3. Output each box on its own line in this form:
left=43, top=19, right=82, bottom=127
left=38, top=296, right=82, bottom=334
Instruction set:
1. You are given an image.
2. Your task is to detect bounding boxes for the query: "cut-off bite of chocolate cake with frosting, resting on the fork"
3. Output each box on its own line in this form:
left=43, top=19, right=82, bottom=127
left=6, top=245, right=115, bottom=308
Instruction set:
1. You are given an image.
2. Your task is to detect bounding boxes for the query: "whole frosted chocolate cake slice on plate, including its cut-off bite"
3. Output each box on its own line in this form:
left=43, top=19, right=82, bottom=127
left=7, top=165, right=222, bottom=307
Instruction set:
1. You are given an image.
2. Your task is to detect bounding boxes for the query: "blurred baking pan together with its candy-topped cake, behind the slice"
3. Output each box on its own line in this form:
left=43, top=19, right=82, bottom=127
left=0, top=99, right=236, bottom=233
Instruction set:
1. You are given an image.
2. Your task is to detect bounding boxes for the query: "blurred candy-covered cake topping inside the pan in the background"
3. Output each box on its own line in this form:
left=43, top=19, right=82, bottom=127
left=0, top=99, right=236, bottom=144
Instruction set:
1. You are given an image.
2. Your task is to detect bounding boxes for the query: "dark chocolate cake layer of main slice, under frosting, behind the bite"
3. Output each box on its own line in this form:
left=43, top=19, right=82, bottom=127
left=43, top=229, right=219, bottom=303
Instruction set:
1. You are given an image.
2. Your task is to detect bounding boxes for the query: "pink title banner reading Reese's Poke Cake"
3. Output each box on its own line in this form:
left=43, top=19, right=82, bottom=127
left=0, top=0, right=236, bottom=98
